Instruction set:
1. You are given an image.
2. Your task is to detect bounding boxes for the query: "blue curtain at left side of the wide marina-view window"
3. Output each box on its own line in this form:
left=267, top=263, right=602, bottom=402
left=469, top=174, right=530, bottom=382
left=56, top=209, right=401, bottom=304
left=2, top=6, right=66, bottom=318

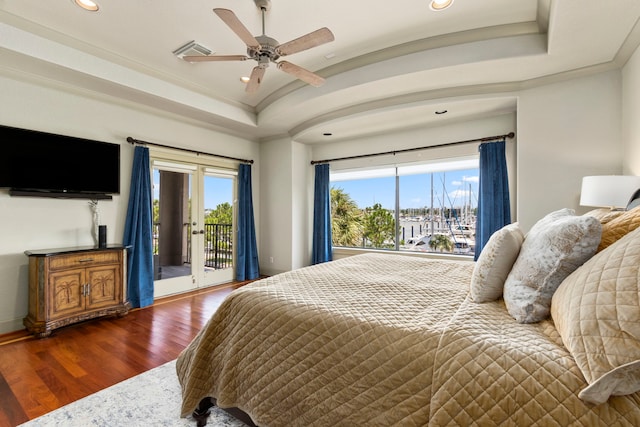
left=311, top=163, right=332, bottom=264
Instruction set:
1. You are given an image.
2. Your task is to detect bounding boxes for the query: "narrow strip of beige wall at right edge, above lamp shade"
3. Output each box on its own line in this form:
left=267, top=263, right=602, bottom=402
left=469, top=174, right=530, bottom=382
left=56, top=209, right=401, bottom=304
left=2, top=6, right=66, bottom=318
left=622, top=44, right=640, bottom=175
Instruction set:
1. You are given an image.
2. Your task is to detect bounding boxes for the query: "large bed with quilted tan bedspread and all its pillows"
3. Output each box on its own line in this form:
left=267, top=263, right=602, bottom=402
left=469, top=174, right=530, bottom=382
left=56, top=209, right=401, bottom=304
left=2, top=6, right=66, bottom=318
left=176, top=209, right=640, bottom=427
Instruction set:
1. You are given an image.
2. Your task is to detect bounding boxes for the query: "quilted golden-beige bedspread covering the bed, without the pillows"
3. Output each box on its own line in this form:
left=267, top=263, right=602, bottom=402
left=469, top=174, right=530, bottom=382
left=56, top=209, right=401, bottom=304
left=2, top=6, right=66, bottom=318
left=176, top=254, right=640, bottom=427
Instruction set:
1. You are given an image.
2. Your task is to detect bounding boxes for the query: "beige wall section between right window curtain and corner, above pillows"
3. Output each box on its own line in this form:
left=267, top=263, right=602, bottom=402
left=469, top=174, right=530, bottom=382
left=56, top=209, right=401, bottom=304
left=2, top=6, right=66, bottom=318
left=517, top=71, right=622, bottom=230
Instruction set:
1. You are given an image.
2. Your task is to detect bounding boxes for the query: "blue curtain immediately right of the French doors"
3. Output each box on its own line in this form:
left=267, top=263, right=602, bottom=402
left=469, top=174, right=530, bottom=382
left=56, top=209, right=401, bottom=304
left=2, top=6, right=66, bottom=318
left=236, top=163, right=260, bottom=281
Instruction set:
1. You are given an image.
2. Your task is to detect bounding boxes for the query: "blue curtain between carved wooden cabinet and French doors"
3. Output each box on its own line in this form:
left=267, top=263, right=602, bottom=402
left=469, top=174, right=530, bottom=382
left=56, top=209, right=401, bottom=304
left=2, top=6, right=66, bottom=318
left=123, top=146, right=153, bottom=307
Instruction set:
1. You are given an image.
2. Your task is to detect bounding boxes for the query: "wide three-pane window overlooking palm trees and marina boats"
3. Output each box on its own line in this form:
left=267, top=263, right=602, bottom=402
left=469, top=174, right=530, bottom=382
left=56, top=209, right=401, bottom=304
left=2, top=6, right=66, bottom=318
left=330, top=155, right=479, bottom=256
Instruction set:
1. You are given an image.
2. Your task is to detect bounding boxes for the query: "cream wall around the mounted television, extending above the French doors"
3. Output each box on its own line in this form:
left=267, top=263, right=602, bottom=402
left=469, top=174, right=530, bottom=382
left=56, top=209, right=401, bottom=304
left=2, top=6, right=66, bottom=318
left=0, top=77, right=260, bottom=334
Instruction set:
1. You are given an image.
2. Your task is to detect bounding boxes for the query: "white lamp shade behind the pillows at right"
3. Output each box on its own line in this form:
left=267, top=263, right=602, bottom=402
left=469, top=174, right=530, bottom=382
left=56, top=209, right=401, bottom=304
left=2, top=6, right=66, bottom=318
left=580, top=175, right=640, bottom=208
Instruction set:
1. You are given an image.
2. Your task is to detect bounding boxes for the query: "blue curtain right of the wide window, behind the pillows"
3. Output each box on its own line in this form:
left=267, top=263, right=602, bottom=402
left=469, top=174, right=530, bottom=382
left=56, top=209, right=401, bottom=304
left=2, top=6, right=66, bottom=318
left=475, top=140, right=511, bottom=260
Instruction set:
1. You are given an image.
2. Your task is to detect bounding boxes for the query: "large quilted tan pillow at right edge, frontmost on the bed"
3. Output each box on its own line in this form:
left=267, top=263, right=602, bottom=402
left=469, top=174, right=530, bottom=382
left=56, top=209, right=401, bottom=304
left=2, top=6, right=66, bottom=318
left=551, top=228, right=640, bottom=404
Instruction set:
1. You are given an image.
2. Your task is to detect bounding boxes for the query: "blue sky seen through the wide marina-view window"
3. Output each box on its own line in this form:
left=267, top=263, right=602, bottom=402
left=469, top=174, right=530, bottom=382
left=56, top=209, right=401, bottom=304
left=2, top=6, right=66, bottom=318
left=331, top=169, right=478, bottom=209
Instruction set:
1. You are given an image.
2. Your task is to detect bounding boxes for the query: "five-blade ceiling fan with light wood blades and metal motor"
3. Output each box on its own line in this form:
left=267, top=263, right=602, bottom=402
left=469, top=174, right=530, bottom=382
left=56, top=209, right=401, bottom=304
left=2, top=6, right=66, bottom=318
left=183, top=0, right=334, bottom=92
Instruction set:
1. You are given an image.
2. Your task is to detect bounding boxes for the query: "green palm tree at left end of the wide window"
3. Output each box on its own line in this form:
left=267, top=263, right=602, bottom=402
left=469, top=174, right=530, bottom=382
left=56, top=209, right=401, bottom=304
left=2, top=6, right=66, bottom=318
left=330, top=187, right=363, bottom=246
